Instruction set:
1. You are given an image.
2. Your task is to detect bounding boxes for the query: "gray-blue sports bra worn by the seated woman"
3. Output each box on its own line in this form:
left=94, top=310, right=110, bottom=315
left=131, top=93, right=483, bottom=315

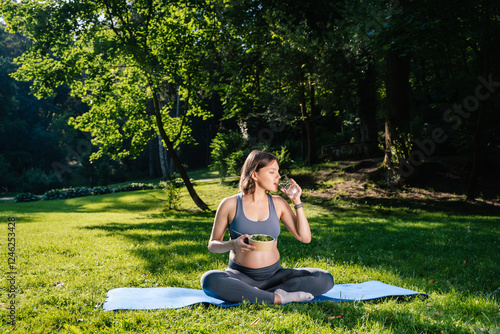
left=229, top=193, right=281, bottom=239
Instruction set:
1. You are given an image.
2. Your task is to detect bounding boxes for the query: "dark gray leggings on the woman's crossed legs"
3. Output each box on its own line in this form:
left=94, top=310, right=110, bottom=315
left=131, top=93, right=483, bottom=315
left=201, top=261, right=333, bottom=304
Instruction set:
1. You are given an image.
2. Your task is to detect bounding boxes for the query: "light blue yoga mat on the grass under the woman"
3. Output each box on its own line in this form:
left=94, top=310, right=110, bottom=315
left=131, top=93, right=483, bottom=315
left=103, top=281, right=427, bottom=311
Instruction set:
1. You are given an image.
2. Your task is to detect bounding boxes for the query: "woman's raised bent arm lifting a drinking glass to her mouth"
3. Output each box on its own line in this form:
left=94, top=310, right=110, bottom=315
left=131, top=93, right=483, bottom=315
left=275, top=179, right=311, bottom=243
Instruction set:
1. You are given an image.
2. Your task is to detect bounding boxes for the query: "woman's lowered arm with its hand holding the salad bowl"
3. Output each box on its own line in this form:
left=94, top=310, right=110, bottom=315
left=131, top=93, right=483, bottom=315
left=208, top=196, right=255, bottom=253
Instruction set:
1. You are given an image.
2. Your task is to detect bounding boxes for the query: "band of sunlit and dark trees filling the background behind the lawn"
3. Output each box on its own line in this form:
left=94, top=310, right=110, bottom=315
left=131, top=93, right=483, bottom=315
left=0, top=0, right=500, bottom=204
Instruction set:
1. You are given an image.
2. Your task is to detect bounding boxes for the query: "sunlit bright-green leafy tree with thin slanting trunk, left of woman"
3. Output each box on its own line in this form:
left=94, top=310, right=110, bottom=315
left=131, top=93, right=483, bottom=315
left=1, top=0, right=218, bottom=210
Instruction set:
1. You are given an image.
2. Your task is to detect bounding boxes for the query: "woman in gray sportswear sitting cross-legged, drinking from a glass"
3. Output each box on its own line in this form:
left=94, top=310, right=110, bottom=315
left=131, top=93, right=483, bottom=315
left=201, top=151, right=333, bottom=304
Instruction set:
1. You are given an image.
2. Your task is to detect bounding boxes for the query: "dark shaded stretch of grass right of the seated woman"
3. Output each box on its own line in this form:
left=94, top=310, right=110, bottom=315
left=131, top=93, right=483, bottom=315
left=296, top=198, right=500, bottom=294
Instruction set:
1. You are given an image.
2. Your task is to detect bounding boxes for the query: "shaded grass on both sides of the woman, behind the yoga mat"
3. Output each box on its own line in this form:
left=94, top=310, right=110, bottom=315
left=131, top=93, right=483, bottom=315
left=84, top=196, right=500, bottom=294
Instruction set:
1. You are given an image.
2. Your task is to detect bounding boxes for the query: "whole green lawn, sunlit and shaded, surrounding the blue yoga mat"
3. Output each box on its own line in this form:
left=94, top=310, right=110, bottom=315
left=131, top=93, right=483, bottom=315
left=0, top=171, right=500, bottom=333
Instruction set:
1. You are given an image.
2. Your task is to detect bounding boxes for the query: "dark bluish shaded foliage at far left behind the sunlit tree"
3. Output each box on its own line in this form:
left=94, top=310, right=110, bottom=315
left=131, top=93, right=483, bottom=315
left=0, top=23, right=101, bottom=194
